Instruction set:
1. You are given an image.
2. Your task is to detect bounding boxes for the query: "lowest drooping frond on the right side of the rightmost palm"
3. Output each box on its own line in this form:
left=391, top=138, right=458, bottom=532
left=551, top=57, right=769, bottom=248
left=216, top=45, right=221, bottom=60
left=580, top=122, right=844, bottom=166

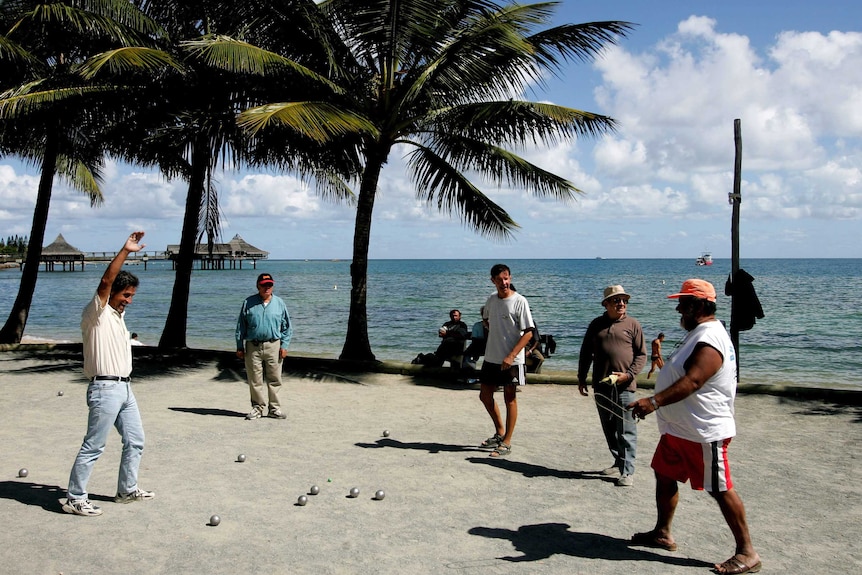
left=408, top=143, right=519, bottom=240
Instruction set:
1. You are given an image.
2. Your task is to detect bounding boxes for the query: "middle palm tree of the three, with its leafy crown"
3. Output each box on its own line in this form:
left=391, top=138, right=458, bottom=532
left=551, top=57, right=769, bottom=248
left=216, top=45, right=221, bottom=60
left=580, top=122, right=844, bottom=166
left=125, top=0, right=358, bottom=348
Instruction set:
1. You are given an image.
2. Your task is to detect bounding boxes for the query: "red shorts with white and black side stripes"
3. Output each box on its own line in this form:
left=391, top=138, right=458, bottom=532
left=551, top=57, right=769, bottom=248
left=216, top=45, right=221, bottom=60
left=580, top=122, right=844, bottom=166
left=651, top=434, right=733, bottom=493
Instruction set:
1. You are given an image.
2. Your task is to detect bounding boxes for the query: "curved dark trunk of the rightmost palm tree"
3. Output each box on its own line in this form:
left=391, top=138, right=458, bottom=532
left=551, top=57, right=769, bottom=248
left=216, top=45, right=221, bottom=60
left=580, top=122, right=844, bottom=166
left=339, top=154, right=386, bottom=361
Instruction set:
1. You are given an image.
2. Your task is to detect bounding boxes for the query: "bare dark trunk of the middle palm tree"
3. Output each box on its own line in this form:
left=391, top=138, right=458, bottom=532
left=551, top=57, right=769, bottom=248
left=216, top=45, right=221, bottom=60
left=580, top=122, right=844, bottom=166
left=159, top=142, right=209, bottom=349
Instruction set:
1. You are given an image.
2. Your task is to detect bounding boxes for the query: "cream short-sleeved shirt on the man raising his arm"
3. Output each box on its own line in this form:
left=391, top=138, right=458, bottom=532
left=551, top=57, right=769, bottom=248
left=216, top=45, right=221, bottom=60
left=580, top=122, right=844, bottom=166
left=81, top=293, right=132, bottom=379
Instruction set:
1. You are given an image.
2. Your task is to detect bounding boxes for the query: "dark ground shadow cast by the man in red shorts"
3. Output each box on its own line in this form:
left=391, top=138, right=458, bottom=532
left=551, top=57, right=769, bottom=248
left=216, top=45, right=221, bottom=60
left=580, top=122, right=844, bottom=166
left=467, top=523, right=713, bottom=567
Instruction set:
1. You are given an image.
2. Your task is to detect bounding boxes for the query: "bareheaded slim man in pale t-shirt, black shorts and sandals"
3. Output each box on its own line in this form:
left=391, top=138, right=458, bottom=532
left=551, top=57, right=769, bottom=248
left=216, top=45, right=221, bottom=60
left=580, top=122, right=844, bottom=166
left=479, top=264, right=536, bottom=457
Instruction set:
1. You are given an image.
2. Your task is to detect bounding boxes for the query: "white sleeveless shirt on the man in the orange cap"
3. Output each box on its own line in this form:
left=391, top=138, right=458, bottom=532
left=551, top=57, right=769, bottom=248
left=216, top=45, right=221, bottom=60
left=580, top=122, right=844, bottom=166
left=655, top=320, right=736, bottom=443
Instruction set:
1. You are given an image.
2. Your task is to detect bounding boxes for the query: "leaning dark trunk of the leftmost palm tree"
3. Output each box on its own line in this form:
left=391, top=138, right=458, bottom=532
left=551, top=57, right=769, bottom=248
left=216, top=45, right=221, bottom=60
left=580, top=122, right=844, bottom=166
left=0, top=133, right=59, bottom=343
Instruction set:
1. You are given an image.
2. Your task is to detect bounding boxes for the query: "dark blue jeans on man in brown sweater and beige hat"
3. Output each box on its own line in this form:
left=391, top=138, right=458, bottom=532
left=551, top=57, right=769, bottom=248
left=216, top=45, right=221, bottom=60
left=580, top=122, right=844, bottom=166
left=593, top=385, right=638, bottom=475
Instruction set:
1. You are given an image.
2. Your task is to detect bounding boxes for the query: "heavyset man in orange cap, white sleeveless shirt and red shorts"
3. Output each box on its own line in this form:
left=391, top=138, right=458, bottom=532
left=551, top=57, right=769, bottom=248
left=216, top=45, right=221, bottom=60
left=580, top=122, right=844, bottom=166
left=627, top=279, right=762, bottom=573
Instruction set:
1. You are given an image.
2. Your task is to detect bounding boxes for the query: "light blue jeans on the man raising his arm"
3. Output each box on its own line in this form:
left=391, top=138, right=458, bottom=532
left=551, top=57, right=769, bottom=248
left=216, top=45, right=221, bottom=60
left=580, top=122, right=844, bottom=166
left=68, top=381, right=144, bottom=499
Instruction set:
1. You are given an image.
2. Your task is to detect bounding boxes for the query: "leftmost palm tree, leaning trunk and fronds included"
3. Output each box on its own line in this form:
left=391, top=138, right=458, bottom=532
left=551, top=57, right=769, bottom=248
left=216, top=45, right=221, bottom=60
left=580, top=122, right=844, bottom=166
left=0, top=0, right=165, bottom=343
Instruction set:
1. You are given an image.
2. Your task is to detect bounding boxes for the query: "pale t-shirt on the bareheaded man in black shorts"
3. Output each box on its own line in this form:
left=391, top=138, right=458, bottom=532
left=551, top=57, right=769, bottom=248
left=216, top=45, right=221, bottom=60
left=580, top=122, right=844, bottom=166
left=482, top=292, right=534, bottom=365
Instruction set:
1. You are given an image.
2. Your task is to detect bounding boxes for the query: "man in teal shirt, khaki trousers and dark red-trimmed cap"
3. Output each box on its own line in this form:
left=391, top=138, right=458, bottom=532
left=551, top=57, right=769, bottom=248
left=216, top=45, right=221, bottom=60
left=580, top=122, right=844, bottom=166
left=236, top=274, right=293, bottom=419
